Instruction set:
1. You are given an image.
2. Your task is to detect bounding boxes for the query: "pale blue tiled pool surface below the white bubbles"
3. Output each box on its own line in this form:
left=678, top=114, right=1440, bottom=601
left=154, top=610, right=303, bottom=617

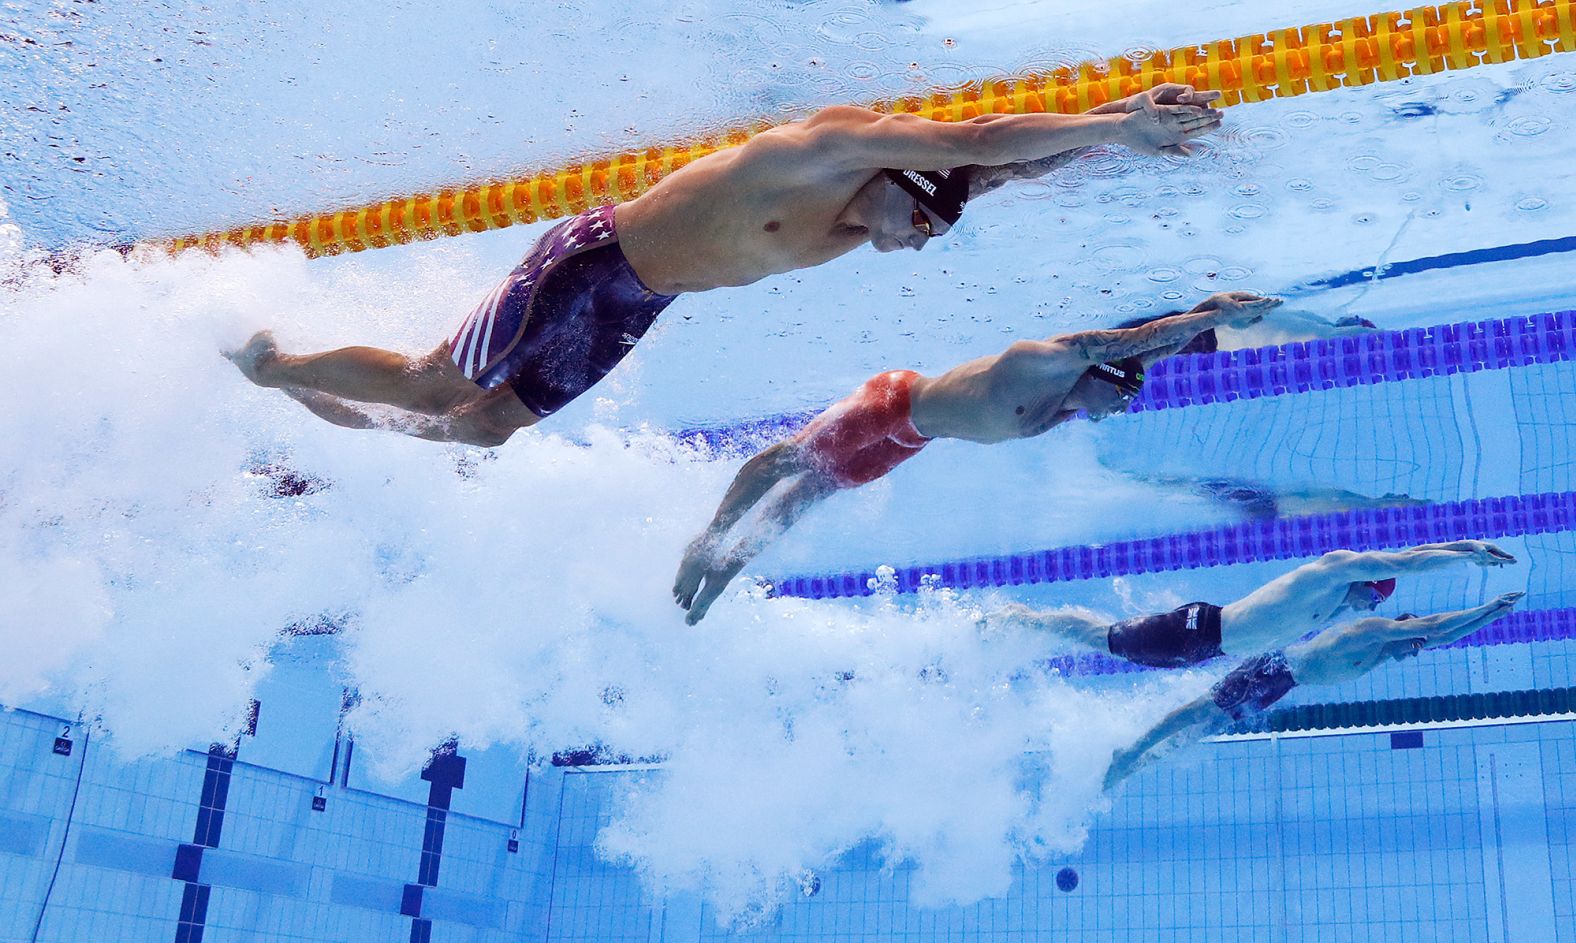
left=0, top=711, right=1576, bottom=943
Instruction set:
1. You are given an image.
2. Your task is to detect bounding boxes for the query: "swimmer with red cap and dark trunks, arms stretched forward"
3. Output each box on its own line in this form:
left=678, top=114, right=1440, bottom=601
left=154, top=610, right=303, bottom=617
left=988, top=541, right=1516, bottom=669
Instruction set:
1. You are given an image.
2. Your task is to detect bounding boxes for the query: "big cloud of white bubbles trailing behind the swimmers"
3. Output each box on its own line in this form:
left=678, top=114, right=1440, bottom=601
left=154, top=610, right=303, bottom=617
left=0, top=249, right=1197, bottom=915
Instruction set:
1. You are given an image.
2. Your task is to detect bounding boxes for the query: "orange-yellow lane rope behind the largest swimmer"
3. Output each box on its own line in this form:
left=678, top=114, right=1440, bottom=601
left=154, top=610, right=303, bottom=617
left=164, top=0, right=1576, bottom=255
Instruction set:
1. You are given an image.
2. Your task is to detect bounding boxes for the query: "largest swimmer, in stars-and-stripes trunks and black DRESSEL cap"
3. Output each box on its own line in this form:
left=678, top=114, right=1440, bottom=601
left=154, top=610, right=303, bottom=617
left=230, top=84, right=1221, bottom=446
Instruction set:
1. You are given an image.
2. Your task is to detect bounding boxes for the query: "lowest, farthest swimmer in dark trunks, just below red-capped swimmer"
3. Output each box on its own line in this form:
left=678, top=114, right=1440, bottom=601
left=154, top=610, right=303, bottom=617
left=1105, top=593, right=1522, bottom=790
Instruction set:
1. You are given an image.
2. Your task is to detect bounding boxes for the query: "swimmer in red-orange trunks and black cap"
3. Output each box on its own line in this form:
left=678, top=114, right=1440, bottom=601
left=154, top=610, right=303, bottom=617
left=673, top=292, right=1280, bottom=624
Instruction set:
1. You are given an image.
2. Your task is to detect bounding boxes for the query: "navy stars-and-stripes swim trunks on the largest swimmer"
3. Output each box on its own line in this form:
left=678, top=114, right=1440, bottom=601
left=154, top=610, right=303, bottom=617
left=449, top=207, right=675, bottom=416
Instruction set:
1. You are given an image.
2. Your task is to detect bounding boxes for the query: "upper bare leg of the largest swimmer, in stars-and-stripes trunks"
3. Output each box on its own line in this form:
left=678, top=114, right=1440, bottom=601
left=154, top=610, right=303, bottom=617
left=225, top=331, right=472, bottom=416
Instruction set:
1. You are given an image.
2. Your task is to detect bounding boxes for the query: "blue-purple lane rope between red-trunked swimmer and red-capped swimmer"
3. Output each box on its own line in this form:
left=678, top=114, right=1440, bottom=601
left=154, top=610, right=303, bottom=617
left=771, top=492, right=1576, bottom=599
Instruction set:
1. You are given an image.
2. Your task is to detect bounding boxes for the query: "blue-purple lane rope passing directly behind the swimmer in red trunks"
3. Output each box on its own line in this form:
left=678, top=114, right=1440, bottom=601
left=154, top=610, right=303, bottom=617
left=676, top=311, right=1576, bottom=454
